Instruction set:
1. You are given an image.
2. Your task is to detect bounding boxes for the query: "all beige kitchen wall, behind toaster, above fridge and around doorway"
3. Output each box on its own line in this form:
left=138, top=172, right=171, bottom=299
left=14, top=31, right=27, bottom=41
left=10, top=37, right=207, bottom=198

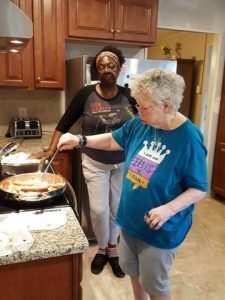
left=0, top=0, right=225, bottom=184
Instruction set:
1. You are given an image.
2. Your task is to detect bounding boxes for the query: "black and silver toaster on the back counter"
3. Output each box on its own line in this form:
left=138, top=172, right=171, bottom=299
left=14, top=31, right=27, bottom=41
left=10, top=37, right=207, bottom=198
left=8, top=118, right=42, bottom=139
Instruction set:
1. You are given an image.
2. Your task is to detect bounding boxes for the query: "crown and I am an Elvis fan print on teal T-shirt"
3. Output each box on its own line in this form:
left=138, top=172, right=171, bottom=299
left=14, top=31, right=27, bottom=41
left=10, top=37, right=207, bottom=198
left=127, top=141, right=170, bottom=189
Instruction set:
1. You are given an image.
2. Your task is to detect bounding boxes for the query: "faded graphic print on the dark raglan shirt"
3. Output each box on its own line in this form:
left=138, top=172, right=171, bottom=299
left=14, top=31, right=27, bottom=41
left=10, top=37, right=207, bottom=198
left=90, top=102, right=134, bottom=133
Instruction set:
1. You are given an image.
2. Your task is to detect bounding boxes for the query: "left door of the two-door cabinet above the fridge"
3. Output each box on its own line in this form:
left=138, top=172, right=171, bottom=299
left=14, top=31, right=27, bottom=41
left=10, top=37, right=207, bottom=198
left=68, top=0, right=114, bottom=39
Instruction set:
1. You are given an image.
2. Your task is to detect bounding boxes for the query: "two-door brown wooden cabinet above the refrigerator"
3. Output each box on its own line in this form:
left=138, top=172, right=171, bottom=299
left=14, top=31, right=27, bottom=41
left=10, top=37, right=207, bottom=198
left=67, top=0, right=158, bottom=45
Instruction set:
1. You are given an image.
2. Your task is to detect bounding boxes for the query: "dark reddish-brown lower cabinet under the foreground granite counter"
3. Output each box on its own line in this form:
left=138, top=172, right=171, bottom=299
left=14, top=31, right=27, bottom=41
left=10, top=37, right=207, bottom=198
left=0, top=253, right=82, bottom=300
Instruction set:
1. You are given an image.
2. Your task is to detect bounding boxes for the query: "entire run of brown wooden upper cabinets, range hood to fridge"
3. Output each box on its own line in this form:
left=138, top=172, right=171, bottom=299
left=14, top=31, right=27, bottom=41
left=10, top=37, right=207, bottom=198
left=0, top=0, right=158, bottom=89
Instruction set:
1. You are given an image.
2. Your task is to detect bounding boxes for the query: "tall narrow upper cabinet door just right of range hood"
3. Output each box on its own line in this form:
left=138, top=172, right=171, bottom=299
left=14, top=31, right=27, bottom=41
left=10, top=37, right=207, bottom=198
left=33, top=0, right=65, bottom=89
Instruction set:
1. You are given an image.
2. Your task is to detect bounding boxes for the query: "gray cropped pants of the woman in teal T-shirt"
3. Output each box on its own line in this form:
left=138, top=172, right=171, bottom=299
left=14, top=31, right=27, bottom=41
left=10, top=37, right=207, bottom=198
left=119, top=229, right=178, bottom=297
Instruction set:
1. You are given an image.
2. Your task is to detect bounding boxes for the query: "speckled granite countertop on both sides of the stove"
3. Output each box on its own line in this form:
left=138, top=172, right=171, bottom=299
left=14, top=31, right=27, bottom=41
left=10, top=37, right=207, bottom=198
left=0, top=126, right=88, bottom=265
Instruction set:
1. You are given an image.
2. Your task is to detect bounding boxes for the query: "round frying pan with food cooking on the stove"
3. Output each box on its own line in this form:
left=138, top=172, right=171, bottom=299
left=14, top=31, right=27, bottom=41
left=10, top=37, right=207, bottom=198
left=0, top=172, right=66, bottom=202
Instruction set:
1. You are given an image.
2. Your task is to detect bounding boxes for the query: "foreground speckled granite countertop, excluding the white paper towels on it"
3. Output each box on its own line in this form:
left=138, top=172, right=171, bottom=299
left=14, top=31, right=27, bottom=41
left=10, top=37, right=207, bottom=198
left=0, top=206, right=88, bottom=265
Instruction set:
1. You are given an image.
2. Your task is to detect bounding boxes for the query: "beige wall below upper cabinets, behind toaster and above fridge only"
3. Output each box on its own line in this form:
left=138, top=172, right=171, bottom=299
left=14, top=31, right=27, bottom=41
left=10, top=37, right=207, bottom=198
left=0, top=43, right=146, bottom=136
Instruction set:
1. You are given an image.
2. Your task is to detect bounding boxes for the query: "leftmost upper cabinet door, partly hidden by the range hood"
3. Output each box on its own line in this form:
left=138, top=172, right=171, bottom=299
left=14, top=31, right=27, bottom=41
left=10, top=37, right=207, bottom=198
left=0, top=0, right=33, bottom=88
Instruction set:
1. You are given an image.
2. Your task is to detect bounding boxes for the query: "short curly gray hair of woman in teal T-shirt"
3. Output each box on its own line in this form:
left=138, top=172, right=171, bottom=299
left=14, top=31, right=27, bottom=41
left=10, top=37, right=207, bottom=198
left=131, top=69, right=185, bottom=113
